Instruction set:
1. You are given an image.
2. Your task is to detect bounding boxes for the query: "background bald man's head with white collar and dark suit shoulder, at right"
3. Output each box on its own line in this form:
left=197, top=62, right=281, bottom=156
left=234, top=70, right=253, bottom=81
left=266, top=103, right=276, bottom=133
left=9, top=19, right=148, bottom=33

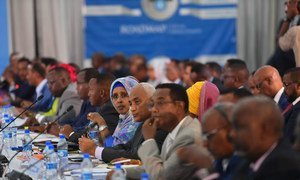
left=254, top=66, right=289, bottom=111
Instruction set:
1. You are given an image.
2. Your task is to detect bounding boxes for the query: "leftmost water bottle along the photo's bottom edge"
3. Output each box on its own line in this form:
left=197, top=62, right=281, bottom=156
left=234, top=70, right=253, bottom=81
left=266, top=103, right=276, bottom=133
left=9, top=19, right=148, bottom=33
left=46, top=145, right=59, bottom=180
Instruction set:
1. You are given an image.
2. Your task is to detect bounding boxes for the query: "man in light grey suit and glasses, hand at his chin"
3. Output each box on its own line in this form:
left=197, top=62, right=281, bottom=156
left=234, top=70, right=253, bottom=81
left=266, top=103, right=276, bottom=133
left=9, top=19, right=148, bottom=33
left=126, top=84, right=201, bottom=179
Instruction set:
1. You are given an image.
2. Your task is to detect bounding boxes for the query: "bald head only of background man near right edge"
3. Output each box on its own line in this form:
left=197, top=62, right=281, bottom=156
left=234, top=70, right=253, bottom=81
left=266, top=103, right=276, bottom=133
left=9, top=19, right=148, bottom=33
left=253, top=66, right=283, bottom=98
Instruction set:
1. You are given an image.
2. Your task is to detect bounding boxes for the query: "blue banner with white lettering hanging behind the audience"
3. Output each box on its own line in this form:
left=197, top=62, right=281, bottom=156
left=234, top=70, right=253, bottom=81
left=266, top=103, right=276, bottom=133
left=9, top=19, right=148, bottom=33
left=83, top=0, right=237, bottom=62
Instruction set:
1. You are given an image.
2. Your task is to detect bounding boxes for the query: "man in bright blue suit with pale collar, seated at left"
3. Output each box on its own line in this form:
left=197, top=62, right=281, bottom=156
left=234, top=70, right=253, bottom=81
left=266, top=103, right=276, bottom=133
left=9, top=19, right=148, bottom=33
left=21, top=62, right=54, bottom=112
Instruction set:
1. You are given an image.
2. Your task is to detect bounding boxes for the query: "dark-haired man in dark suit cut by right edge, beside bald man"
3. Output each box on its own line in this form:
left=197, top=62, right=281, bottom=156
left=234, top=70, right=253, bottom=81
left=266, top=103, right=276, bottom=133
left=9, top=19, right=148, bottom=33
left=283, top=67, right=300, bottom=142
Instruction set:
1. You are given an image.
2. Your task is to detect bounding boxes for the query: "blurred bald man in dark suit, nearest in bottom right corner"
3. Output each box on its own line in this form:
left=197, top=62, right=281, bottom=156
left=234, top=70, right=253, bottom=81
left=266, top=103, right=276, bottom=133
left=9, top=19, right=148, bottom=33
left=230, top=96, right=300, bottom=180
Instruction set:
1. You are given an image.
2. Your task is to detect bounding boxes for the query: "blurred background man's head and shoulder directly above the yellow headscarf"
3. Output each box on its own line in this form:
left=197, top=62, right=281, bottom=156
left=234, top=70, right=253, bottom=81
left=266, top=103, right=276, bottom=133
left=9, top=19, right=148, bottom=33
left=190, top=63, right=224, bottom=91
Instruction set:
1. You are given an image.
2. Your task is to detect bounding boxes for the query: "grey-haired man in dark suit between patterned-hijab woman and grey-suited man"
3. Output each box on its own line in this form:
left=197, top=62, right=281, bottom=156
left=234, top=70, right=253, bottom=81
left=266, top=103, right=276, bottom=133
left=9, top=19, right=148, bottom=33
left=79, top=83, right=167, bottom=162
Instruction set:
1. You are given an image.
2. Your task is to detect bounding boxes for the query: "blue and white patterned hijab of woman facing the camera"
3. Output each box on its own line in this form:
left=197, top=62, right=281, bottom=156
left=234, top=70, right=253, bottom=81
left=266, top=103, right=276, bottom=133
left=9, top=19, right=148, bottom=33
left=110, top=76, right=140, bottom=146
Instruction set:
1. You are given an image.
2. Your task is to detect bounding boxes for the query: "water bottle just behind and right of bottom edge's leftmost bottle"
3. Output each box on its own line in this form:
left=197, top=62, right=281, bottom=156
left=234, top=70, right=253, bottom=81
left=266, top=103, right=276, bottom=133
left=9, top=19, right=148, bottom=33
left=57, top=134, right=68, bottom=176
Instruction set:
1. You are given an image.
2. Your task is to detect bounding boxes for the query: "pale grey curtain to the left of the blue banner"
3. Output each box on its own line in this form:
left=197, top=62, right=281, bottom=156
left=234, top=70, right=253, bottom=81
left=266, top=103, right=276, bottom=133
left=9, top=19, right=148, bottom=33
left=10, top=0, right=83, bottom=67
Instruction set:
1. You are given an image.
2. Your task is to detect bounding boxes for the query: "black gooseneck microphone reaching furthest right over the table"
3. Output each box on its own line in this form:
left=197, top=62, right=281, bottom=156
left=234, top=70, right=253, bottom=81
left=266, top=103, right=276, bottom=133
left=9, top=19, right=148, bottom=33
left=3, top=105, right=74, bottom=178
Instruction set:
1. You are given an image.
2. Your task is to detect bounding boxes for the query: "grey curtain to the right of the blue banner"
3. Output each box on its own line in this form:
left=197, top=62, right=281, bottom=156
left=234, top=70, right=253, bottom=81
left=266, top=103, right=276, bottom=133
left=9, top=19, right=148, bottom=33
left=237, top=0, right=284, bottom=71
